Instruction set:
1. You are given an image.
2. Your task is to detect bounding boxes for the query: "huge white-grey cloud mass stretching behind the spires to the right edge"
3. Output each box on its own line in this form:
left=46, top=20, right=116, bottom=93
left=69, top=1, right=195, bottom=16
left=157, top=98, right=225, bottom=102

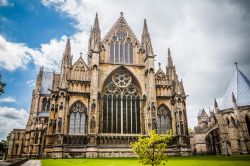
left=0, top=0, right=250, bottom=127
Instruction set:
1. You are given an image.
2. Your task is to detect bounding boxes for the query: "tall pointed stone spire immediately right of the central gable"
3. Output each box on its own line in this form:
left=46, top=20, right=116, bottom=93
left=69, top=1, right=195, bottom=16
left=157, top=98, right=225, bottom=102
left=141, top=19, right=154, bottom=56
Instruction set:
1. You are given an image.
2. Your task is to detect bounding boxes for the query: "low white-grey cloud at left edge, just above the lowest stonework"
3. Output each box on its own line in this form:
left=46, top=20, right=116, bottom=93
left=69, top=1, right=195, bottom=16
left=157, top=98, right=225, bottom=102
left=0, top=107, right=28, bottom=140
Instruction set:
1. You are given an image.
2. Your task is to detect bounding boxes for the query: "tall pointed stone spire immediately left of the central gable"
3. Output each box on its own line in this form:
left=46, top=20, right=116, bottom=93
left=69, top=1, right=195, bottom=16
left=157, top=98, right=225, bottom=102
left=89, top=13, right=101, bottom=51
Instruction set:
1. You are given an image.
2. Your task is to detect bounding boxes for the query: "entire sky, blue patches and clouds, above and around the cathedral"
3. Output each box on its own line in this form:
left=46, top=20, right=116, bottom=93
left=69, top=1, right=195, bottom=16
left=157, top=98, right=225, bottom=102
left=0, top=0, right=250, bottom=140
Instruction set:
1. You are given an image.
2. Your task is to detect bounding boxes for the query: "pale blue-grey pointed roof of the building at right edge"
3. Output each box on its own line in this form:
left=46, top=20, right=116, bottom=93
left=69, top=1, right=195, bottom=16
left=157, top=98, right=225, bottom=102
left=219, top=64, right=250, bottom=110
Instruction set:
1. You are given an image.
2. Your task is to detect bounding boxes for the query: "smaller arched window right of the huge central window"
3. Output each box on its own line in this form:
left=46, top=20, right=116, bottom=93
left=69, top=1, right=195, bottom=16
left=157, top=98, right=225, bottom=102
left=157, top=105, right=172, bottom=134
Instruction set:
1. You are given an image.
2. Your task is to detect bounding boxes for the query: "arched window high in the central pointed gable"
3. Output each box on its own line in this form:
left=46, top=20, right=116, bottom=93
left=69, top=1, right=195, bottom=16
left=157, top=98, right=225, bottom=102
left=110, top=31, right=133, bottom=64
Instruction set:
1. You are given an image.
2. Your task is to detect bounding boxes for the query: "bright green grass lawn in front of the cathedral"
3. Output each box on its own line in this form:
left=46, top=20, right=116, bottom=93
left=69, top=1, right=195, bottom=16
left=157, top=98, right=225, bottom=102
left=42, top=155, right=250, bottom=166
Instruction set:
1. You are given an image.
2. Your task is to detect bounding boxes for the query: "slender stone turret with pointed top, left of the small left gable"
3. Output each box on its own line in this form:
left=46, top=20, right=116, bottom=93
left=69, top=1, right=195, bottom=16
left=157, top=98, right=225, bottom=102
left=60, top=39, right=72, bottom=88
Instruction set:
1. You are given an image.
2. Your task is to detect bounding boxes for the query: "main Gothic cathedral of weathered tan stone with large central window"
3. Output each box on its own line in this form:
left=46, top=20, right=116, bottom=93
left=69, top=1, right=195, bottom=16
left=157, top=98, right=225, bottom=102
left=8, top=13, right=190, bottom=158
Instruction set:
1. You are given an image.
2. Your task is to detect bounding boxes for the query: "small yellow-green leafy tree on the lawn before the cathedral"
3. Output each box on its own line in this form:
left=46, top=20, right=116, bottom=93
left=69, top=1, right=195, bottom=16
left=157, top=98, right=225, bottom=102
left=132, top=130, right=173, bottom=166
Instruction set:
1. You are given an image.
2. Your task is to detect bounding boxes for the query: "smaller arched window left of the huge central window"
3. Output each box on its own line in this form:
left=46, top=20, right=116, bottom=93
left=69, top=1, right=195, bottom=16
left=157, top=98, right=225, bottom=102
left=69, top=102, right=87, bottom=134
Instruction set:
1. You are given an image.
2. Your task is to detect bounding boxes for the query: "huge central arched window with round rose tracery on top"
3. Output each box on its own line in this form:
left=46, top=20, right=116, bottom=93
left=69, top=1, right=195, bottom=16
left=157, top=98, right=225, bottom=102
left=102, top=70, right=141, bottom=134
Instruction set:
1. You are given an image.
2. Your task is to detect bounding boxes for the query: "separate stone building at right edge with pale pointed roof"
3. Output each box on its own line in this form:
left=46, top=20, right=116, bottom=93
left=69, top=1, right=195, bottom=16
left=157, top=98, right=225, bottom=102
left=191, top=66, right=250, bottom=155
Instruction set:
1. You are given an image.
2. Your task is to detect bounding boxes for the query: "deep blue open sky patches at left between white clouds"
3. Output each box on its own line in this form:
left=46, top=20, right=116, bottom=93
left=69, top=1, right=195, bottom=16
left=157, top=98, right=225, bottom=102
left=0, top=0, right=76, bottom=139
